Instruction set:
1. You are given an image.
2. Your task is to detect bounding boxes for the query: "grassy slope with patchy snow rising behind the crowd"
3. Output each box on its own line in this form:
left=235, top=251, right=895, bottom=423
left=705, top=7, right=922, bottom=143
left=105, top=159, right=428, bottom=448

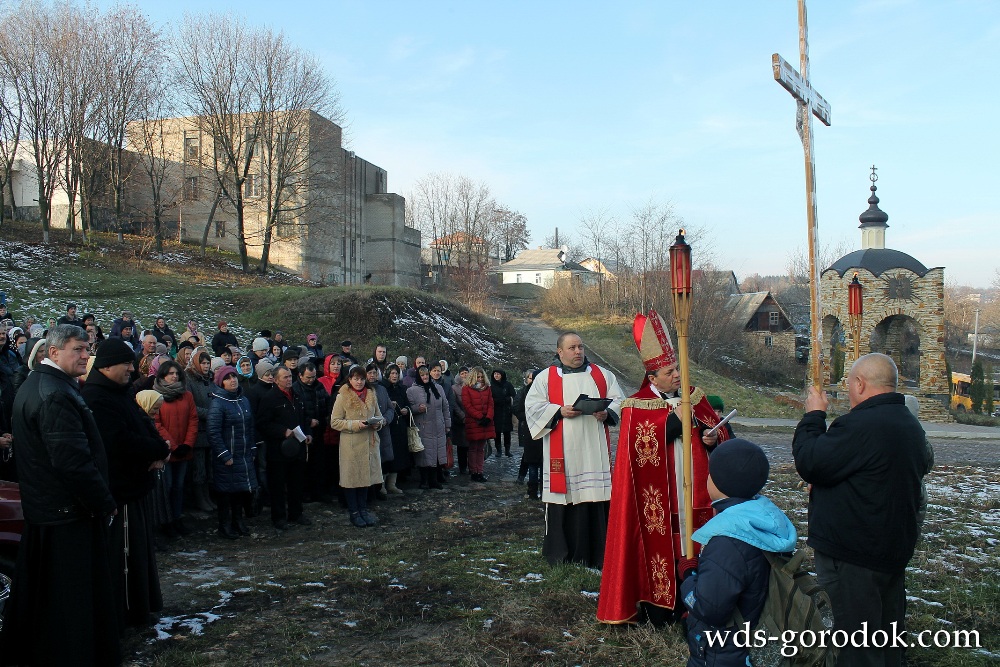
left=0, top=225, right=538, bottom=369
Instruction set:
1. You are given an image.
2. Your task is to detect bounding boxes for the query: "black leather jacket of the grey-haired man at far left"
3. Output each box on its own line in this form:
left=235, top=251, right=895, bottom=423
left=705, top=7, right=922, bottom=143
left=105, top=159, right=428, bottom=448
left=13, top=364, right=117, bottom=525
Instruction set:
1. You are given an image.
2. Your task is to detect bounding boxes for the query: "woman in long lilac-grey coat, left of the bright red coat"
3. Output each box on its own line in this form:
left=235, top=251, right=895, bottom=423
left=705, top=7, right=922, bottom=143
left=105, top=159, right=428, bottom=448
left=406, top=364, right=451, bottom=489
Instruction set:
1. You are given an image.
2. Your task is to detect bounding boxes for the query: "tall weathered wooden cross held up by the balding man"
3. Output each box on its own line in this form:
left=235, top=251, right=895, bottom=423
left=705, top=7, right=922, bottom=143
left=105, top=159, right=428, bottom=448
left=771, top=0, right=830, bottom=390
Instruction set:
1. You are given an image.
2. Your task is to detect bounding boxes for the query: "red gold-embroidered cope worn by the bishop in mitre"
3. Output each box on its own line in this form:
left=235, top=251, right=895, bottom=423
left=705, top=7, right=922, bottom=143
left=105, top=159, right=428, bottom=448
left=597, top=384, right=727, bottom=623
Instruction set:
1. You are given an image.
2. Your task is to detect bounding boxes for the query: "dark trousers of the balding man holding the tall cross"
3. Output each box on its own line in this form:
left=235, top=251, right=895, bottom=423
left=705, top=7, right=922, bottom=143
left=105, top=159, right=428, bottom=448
left=815, top=551, right=906, bottom=667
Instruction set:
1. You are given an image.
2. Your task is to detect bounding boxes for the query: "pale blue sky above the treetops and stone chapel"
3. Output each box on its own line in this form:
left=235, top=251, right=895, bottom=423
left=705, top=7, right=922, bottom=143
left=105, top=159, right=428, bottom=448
left=107, top=0, right=1000, bottom=287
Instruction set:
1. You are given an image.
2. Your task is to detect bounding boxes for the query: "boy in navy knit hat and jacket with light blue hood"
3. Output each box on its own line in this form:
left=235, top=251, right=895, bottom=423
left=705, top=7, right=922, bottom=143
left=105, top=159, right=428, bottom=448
left=677, top=438, right=796, bottom=667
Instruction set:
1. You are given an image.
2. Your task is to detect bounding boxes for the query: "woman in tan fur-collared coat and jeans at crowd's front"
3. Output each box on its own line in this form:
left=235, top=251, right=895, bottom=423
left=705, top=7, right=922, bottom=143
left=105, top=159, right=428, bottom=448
left=330, top=364, right=385, bottom=528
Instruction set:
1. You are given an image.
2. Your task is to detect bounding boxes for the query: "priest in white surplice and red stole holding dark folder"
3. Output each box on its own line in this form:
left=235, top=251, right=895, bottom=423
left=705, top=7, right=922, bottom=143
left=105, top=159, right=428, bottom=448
left=524, top=332, right=622, bottom=568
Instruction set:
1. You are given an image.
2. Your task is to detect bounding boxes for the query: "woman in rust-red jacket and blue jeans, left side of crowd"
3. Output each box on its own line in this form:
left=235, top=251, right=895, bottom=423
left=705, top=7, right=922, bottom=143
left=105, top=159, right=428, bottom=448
left=153, top=361, right=198, bottom=535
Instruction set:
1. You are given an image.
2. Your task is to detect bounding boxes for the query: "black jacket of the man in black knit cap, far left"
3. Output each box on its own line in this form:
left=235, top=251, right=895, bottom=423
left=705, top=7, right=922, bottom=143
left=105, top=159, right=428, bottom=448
left=80, top=368, right=170, bottom=505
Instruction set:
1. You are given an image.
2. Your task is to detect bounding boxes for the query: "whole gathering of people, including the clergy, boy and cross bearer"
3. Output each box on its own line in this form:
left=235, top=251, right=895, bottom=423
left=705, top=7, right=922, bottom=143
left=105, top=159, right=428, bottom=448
left=0, top=304, right=933, bottom=666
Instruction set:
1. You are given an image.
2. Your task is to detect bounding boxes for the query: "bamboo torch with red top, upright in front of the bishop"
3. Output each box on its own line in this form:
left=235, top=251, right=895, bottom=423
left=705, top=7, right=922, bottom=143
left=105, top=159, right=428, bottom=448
left=670, top=229, right=694, bottom=558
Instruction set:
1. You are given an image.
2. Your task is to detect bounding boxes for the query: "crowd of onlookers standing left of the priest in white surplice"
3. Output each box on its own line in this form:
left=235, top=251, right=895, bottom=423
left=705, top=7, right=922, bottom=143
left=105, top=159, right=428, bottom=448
left=0, top=303, right=541, bottom=664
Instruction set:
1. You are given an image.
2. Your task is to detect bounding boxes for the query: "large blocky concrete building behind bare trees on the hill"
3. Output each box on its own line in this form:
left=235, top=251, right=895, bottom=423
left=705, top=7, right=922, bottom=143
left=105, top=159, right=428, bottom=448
left=128, top=111, right=420, bottom=287
